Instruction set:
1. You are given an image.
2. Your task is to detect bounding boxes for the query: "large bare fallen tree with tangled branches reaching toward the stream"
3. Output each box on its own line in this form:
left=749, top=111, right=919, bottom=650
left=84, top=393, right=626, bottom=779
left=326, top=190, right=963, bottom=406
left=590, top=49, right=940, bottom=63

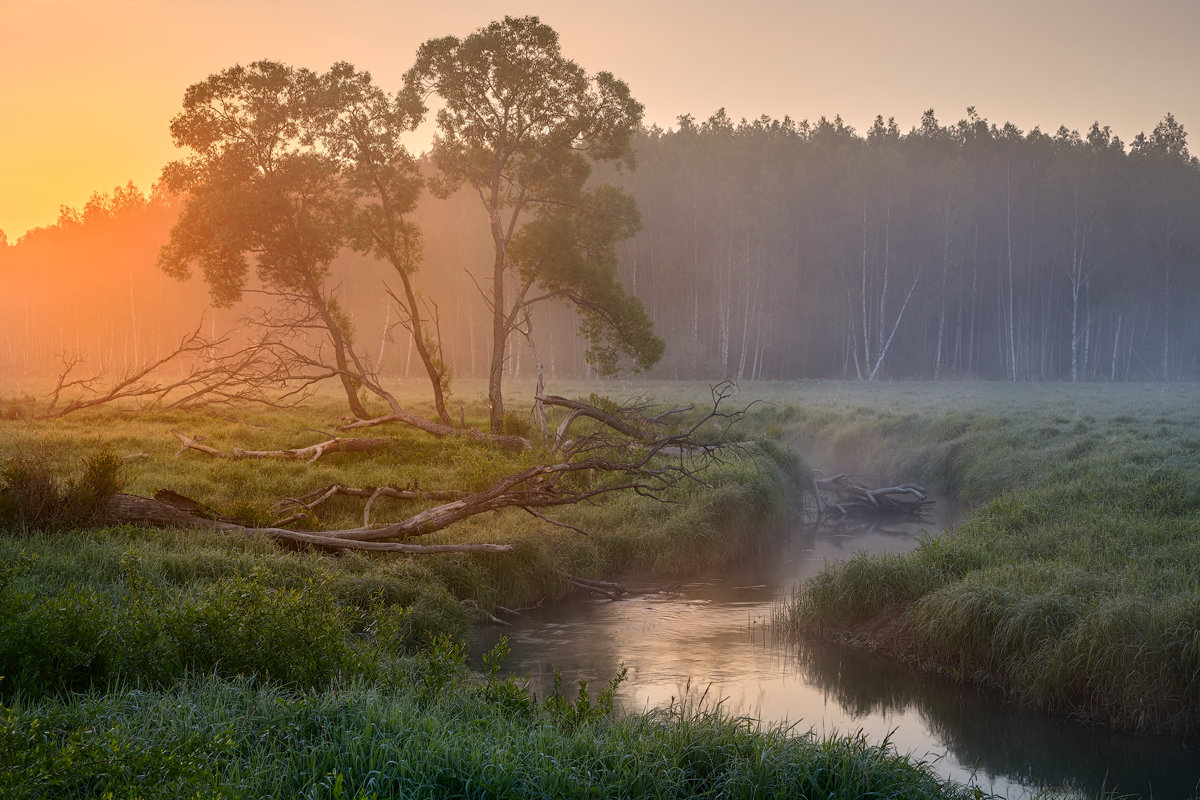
left=100, top=383, right=745, bottom=553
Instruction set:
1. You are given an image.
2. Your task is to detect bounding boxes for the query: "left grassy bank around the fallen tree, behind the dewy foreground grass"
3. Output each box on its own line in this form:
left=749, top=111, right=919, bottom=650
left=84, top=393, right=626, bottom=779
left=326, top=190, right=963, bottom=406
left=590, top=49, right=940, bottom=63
left=0, top=381, right=800, bottom=692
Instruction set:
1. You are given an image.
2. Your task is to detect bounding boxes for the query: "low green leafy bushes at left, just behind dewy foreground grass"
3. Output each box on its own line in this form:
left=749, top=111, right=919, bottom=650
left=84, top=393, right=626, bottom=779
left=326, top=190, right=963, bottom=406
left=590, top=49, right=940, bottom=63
left=0, top=553, right=456, bottom=696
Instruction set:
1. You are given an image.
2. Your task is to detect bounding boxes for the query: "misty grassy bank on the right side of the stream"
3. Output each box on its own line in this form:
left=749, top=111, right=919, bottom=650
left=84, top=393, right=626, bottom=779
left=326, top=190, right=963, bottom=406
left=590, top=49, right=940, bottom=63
left=781, top=384, right=1200, bottom=733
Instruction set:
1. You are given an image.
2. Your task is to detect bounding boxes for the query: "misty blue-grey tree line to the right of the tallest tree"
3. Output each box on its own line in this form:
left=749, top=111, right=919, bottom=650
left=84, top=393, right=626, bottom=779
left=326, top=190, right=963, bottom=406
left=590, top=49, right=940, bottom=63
left=609, top=109, right=1200, bottom=380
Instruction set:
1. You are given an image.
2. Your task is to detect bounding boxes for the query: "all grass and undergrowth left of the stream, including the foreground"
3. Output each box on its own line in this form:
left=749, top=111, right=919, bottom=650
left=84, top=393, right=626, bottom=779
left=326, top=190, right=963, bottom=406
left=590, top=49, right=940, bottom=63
left=0, top=381, right=988, bottom=799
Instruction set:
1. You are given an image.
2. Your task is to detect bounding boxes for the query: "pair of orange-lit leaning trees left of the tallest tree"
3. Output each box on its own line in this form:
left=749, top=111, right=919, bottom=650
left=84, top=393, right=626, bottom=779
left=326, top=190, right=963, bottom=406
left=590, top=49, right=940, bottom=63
left=160, top=61, right=441, bottom=425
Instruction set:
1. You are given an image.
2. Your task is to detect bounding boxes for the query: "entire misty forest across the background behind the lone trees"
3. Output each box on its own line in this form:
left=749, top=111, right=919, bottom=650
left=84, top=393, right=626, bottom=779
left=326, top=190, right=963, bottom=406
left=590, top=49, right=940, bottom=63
left=0, top=109, right=1200, bottom=381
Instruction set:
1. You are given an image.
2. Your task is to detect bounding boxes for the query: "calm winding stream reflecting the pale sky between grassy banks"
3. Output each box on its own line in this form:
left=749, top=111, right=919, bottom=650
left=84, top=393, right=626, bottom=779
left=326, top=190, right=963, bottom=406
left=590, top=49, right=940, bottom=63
left=475, top=515, right=1200, bottom=798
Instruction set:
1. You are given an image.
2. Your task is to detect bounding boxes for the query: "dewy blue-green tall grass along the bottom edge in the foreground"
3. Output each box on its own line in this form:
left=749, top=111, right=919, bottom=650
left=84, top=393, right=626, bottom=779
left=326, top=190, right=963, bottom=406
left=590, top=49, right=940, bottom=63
left=0, top=678, right=979, bottom=800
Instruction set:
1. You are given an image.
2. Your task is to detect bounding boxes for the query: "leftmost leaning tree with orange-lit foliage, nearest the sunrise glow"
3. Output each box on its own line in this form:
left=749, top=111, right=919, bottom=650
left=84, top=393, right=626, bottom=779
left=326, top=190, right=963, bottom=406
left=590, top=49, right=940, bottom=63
left=160, top=61, right=367, bottom=417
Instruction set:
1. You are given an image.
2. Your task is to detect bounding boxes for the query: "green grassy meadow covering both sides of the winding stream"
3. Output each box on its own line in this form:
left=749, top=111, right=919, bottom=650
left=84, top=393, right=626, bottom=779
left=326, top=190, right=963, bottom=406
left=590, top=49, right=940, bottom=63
left=9, top=381, right=1200, bottom=799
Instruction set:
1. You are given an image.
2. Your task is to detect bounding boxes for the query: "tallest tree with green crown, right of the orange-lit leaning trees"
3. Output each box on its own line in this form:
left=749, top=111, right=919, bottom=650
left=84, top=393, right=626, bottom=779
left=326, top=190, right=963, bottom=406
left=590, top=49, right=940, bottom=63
left=406, top=17, right=662, bottom=433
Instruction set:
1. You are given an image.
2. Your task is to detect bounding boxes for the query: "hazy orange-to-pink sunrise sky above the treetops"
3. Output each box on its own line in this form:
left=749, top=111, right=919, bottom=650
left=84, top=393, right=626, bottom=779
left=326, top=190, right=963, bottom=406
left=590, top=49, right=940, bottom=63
left=0, top=0, right=1200, bottom=237
